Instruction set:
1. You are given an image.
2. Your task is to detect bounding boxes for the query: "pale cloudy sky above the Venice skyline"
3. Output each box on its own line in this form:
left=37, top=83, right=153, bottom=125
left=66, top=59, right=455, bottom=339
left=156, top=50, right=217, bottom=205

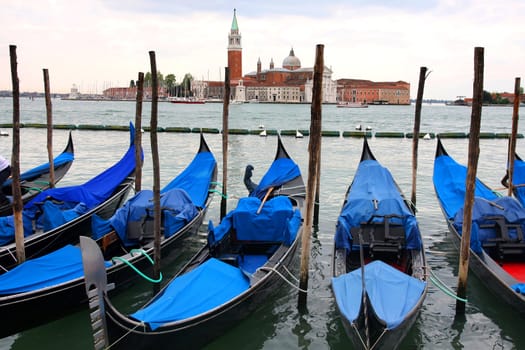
left=0, top=0, right=525, bottom=100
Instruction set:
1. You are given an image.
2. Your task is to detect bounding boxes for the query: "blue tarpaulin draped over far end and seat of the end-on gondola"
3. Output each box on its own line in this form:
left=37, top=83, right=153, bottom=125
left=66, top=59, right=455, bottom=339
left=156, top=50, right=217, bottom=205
left=335, top=160, right=422, bottom=250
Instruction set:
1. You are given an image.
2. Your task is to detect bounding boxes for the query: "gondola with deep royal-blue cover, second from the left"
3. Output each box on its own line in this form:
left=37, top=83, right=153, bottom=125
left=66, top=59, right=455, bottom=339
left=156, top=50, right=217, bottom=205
left=0, top=123, right=140, bottom=274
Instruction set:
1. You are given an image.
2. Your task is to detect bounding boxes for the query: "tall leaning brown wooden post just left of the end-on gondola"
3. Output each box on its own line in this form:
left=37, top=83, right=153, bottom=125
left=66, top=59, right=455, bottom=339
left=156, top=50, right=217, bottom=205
left=298, top=44, right=324, bottom=308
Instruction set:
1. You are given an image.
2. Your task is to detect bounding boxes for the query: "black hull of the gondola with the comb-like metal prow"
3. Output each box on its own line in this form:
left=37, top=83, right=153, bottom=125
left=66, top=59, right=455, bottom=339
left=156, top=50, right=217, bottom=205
left=104, top=232, right=301, bottom=349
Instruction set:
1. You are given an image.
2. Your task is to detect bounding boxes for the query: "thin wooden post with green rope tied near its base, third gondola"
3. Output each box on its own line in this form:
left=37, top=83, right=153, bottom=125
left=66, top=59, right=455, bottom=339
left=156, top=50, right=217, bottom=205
left=148, top=51, right=161, bottom=290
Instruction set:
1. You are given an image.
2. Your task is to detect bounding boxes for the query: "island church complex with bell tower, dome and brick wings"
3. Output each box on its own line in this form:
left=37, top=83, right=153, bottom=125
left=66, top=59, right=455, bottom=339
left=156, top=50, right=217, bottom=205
left=192, top=10, right=410, bottom=105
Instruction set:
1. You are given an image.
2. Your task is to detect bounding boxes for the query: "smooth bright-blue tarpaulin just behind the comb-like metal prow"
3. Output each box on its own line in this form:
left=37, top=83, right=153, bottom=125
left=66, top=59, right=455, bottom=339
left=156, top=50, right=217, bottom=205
left=131, top=258, right=250, bottom=331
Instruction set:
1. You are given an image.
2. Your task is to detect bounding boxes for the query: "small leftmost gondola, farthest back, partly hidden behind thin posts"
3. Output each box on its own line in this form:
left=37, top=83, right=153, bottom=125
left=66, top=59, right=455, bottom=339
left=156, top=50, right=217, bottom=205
left=0, top=132, right=75, bottom=216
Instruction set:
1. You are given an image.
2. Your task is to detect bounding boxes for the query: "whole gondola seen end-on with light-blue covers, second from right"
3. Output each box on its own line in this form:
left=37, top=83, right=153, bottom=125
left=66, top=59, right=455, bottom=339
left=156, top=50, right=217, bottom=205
left=332, top=138, right=428, bottom=349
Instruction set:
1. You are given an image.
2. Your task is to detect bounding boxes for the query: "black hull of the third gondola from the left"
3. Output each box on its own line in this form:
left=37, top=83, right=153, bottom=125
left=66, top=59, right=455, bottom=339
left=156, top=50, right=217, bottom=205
left=0, top=204, right=206, bottom=338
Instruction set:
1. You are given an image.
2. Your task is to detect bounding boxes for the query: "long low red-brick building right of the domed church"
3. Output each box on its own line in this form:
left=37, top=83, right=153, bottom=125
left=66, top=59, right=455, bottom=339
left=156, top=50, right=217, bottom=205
left=337, top=79, right=410, bottom=105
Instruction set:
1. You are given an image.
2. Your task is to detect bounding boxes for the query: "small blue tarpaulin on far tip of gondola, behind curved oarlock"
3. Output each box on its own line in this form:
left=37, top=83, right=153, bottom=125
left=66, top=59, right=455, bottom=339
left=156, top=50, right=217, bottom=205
left=250, top=158, right=301, bottom=199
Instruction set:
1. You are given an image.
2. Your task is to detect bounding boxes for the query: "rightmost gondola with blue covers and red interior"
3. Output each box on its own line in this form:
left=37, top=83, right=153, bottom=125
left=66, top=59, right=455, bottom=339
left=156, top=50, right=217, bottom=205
left=433, top=139, right=525, bottom=314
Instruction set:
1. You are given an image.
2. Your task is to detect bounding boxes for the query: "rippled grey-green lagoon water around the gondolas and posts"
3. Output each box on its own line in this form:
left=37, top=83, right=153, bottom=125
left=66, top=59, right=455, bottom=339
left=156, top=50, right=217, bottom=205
left=0, top=99, right=525, bottom=350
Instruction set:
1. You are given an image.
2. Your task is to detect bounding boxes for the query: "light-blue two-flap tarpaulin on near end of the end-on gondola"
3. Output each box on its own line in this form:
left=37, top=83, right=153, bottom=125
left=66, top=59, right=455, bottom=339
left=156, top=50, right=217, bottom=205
left=332, top=260, right=426, bottom=329
